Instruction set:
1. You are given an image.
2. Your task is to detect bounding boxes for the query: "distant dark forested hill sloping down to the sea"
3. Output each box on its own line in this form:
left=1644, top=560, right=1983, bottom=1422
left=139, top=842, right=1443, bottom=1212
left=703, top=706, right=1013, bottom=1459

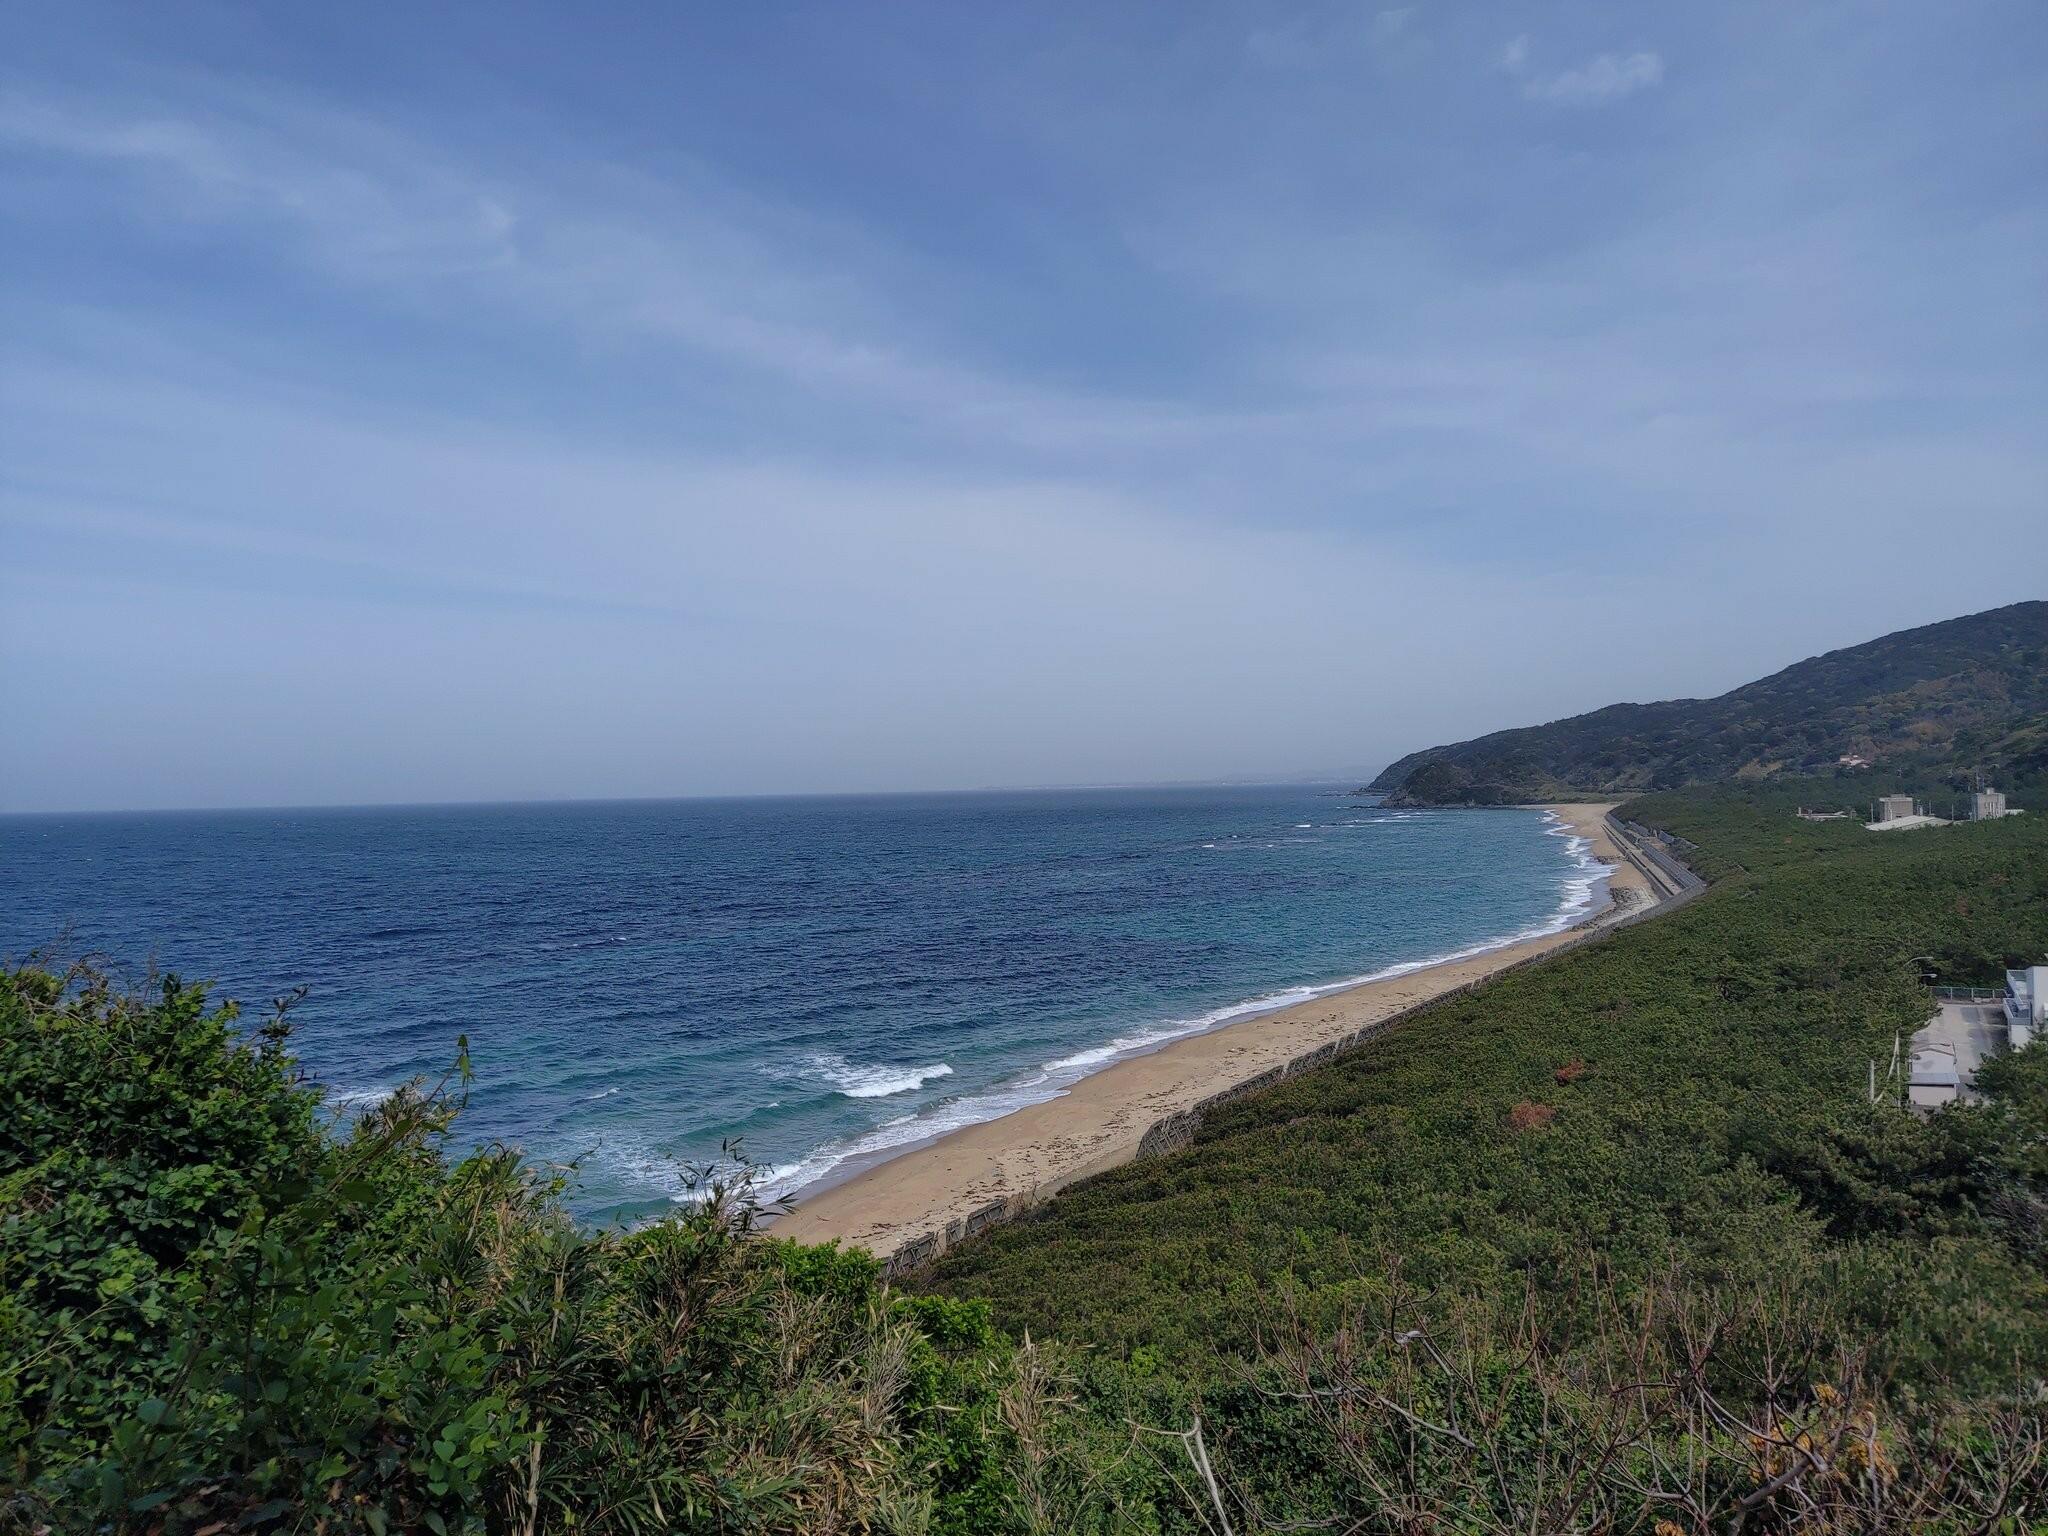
left=1372, top=602, right=2048, bottom=805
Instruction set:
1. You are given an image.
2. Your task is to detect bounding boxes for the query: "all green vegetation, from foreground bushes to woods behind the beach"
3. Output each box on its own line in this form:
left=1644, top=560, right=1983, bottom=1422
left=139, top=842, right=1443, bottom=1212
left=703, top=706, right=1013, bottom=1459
left=0, top=793, right=2048, bottom=1536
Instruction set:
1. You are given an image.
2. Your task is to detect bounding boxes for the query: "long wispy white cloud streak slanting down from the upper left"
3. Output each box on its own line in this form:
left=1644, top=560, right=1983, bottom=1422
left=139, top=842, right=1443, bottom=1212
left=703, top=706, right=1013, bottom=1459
left=0, top=92, right=1214, bottom=456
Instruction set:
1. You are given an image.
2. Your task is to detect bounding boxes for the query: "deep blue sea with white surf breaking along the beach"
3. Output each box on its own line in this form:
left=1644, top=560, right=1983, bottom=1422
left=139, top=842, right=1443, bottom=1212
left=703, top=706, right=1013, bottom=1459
left=0, top=786, right=1599, bottom=1217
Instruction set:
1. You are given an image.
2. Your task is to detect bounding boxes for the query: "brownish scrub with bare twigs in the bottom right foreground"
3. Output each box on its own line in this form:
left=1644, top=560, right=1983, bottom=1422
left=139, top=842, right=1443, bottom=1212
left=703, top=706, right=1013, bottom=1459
left=1243, top=1264, right=2048, bottom=1536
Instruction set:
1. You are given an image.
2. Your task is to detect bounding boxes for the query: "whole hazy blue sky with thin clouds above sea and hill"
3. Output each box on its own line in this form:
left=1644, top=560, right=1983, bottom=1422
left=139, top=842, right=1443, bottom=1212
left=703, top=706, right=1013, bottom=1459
left=0, top=0, right=2048, bottom=811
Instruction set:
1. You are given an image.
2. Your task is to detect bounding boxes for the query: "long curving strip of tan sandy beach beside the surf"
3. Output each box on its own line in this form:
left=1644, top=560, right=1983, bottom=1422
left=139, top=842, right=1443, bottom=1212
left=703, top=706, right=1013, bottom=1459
left=774, top=805, right=1657, bottom=1255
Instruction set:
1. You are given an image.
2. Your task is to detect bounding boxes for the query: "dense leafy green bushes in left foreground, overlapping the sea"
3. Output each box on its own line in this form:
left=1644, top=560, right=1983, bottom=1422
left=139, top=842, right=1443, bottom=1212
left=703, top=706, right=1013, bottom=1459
left=0, top=969, right=1171, bottom=1534
